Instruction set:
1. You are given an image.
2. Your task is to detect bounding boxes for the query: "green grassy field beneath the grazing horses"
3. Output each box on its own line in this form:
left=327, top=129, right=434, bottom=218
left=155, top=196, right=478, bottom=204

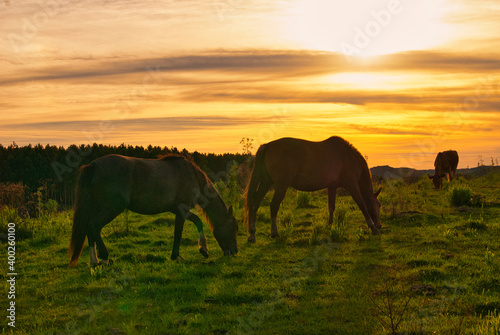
left=0, top=173, right=500, bottom=335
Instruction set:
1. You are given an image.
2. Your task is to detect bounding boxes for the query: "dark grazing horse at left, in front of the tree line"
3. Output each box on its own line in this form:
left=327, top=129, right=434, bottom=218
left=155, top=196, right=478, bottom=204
left=68, top=155, right=238, bottom=267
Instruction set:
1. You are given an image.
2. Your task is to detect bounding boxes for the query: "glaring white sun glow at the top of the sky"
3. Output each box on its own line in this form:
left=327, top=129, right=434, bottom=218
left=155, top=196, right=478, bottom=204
left=284, top=0, right=450, bottom=56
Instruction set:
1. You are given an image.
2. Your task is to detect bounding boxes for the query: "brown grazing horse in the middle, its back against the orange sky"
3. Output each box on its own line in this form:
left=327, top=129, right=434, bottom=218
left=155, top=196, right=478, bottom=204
left=245, top=136, right=382, bottom=242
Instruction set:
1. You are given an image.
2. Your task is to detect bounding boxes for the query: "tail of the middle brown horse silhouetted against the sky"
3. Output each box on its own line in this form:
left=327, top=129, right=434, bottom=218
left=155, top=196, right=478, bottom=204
left=245, top=144, right=269, bottom=231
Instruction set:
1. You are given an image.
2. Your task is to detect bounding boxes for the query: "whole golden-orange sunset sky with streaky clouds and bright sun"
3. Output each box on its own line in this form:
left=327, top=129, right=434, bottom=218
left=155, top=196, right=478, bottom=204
left=0, top=0, right=500, bottom=169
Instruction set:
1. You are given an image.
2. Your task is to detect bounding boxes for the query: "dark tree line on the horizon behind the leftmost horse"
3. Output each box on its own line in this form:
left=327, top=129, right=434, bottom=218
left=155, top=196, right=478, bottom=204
left=0, top=142, right=249, bottom=213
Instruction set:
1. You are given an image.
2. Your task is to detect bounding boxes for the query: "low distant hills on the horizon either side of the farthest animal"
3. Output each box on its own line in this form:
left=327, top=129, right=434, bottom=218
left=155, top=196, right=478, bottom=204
left=370, top=165, right=500, bottom=179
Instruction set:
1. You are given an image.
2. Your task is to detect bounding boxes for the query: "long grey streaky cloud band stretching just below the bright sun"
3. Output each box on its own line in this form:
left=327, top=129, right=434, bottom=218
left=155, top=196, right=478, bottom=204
left=0, top=50, right=500, bottom=85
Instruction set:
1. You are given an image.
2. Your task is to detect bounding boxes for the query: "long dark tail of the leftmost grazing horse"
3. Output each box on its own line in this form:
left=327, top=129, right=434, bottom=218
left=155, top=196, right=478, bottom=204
left=68, top=164, right=94, bottom=267
